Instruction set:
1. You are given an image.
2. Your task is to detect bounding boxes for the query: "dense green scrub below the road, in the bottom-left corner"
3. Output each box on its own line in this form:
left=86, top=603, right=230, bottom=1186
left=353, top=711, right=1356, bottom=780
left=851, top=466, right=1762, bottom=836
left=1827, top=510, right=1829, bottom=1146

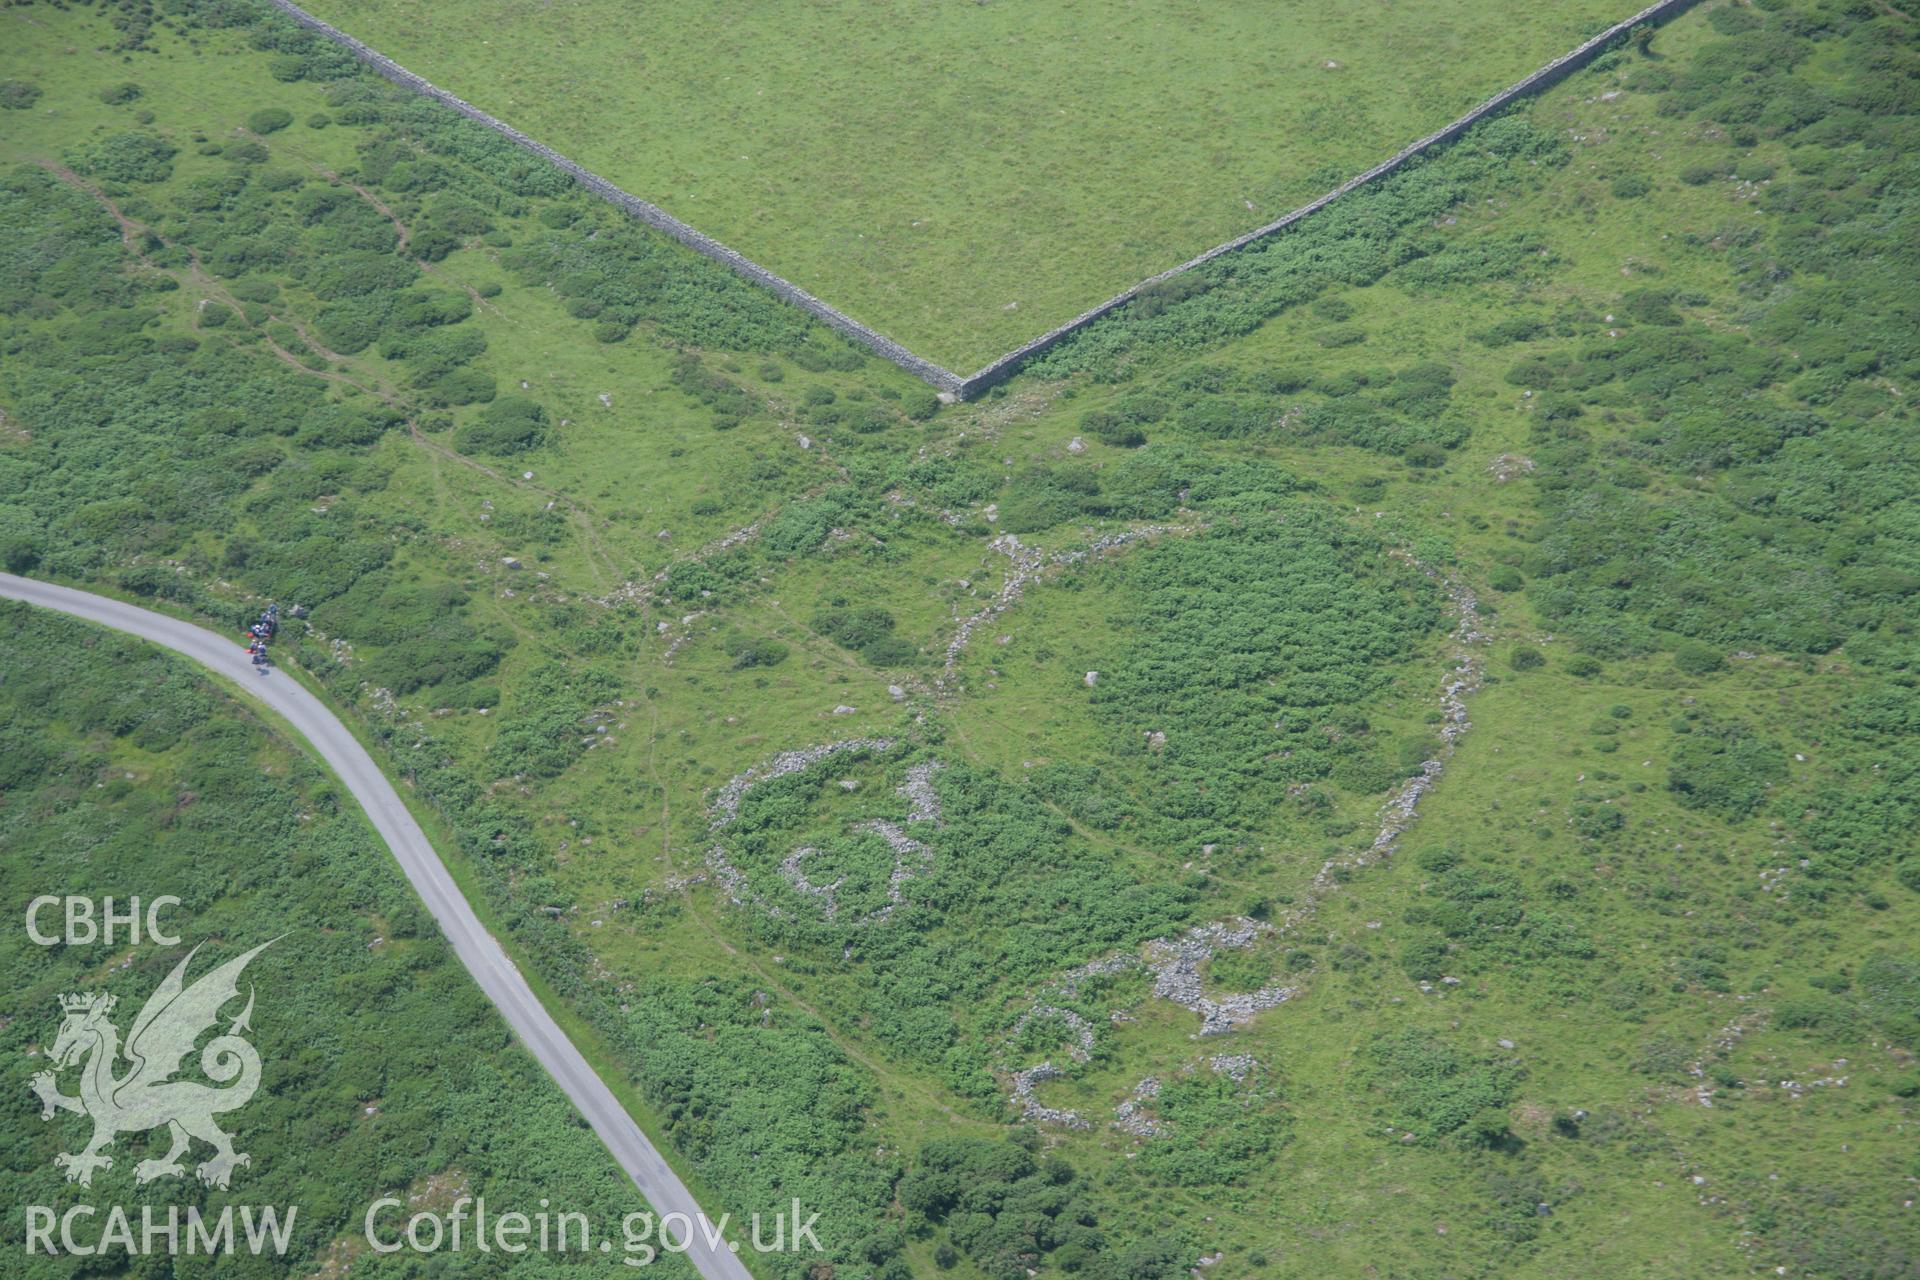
left=0, top=603, right=691, bottom=1276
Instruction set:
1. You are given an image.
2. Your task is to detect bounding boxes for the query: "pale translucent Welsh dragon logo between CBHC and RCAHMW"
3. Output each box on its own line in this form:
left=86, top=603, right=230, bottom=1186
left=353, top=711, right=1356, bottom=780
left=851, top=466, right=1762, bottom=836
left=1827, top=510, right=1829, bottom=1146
left=33, top=942, right=273, bottom=1188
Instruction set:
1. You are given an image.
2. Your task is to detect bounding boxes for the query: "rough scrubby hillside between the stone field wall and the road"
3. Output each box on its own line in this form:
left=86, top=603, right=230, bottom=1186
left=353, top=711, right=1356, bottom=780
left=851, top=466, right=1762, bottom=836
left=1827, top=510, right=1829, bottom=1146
left=0, top=2, right=1920, bottom=1280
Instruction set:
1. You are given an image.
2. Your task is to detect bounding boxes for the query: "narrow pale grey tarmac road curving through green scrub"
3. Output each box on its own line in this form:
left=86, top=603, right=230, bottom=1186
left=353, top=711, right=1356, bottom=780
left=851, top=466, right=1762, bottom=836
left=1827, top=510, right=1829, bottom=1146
left=0, top=574, right=751, bottom=1280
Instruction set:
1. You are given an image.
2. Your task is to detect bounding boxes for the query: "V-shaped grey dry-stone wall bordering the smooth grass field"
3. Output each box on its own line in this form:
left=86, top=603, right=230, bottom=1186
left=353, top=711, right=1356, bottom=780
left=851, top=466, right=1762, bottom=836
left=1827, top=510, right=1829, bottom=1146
left=267, top=0, right=1695, bottom=399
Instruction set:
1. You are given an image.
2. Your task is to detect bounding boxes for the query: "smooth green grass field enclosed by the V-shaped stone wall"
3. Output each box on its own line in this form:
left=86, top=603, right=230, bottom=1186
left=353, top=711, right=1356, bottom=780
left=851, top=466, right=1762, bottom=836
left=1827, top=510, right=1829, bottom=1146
left=299, top=0, right=1632, bottom=372
